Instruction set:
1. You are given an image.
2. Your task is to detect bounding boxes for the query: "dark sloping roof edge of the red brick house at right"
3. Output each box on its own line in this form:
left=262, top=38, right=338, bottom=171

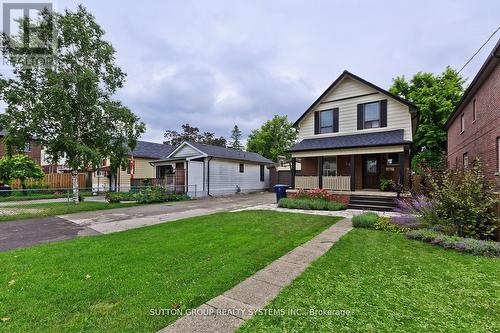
left=445, top=39, right=500, bottom=129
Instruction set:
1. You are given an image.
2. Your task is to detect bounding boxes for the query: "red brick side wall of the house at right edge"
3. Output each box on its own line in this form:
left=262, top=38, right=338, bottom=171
left=448, top=61, right=500, bottom=189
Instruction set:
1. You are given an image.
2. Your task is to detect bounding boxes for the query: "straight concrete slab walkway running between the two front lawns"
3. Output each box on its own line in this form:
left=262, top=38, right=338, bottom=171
left=159, top=219, right=352, bottom=333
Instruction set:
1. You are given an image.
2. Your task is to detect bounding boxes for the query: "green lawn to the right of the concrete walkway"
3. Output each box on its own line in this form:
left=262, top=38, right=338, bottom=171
left=241, top=229, right=500, bottom=332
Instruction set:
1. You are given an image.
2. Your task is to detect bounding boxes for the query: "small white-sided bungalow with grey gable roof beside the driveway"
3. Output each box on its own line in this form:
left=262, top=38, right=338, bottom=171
left=151, top=142, right=273, bottom=197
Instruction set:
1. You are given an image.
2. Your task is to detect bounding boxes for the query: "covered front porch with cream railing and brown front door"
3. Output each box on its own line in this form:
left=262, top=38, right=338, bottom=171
left=292, top=146, right=410, bottom=192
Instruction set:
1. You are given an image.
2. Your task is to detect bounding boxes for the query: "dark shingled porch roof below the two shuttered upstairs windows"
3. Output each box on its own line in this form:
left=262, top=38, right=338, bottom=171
left=289, top=129, right=411, bottom=152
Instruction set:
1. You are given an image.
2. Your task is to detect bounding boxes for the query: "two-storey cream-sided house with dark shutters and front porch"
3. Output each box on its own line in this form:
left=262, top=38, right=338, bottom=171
left=290, top=71, right=417, bottom=191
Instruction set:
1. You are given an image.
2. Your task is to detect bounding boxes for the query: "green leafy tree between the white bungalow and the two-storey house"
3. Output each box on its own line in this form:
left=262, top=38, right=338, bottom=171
left=247, top=115, right=297, bottom=162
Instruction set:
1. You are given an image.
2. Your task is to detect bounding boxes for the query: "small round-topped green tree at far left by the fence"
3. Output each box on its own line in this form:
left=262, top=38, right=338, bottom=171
left=0, top=154, right=45, bottom=190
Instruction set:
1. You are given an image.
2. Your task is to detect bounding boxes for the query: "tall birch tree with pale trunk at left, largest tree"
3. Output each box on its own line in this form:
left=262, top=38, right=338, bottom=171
left=0, top=5, right=145, bottom=204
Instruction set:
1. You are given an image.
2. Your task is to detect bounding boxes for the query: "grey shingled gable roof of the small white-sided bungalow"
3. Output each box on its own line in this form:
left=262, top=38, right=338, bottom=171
left=162, top=141, right=274, bottom=164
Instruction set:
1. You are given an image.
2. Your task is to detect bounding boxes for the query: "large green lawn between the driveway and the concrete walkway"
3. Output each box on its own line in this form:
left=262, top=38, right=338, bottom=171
left=0, top=211, right=338, bottom=332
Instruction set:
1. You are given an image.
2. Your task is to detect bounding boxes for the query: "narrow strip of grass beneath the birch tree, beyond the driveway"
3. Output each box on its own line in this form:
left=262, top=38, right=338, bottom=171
left=0, top=201, right=140, bottom=222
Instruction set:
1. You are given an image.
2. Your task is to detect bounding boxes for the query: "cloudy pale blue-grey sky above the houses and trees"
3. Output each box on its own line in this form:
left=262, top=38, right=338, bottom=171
left=4, top=0, right=500, bottom=142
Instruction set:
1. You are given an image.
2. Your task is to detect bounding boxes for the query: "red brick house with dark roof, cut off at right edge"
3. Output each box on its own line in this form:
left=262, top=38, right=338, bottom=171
left=446, top=40, right=500, bottom=189
